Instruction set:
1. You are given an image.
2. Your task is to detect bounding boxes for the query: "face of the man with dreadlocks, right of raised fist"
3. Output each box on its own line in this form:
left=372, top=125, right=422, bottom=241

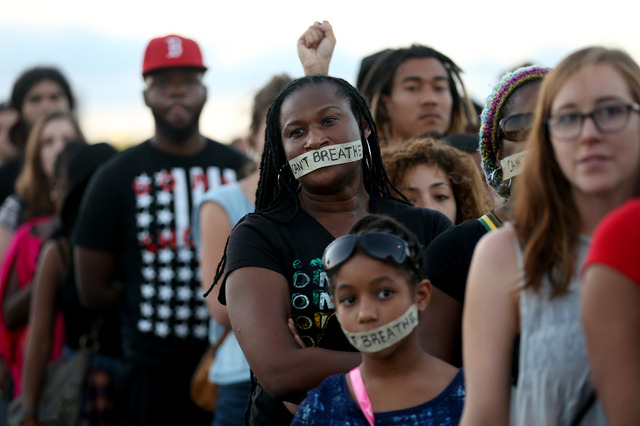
left=382, top=58, right=453, bottom=140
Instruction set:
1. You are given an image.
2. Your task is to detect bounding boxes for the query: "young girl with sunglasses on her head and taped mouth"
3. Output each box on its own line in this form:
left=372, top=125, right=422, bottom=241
left=292, top=214, right=465, bottom=425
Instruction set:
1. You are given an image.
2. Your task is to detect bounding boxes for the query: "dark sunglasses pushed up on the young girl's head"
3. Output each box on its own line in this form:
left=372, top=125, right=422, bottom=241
left=322, top=232, right=418, bottom=272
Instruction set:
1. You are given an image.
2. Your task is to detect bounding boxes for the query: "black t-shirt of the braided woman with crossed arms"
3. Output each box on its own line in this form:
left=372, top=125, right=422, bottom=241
left=220, top=196, right=452, bottom=424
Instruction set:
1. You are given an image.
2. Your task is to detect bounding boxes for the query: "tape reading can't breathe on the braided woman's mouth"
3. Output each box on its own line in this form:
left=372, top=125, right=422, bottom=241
left=289, top=139, right=363, bottom=179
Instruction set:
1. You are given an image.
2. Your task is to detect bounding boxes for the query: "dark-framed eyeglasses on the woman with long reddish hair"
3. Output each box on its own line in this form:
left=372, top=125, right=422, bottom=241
left=547, top=102, right=640, bottom=141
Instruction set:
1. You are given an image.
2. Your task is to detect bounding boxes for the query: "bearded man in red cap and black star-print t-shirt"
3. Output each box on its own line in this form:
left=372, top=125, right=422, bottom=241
left=74, top=35, right=248, bottom=426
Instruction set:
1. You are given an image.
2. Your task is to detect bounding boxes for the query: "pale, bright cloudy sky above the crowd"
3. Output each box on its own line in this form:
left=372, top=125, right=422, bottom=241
left=0, top=0, right=640, bottom=145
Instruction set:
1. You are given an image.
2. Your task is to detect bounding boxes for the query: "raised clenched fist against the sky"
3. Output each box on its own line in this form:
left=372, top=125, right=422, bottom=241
left=298, top=21, right=336, bottom=75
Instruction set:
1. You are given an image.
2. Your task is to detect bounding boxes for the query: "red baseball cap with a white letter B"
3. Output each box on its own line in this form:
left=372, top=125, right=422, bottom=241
left=142, top=34, right=207, bottom=76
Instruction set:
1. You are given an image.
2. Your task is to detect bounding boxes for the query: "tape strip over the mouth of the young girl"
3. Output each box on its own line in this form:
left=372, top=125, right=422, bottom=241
left=340, top=304, right=418, bottom=353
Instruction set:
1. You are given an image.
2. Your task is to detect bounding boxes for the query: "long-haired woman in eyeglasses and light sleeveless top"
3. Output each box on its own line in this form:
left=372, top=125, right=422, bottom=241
left=463, top=47, right=640, bottom=425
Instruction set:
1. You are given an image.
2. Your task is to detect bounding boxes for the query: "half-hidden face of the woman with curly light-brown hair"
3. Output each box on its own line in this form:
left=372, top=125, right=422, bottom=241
left=398, top=164, right=457, bottom=223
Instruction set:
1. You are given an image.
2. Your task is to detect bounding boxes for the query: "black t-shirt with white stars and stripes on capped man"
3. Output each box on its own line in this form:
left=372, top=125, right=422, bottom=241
left=74, top=140, right=248, bottom=365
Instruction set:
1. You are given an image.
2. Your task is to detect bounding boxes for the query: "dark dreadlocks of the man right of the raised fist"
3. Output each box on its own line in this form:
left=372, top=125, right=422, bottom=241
left=361, top=44, right=478, bottom=145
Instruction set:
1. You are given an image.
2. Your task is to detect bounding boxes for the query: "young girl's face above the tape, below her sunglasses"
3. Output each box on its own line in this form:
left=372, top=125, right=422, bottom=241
left=332, top=253, right=429, bottom=350
